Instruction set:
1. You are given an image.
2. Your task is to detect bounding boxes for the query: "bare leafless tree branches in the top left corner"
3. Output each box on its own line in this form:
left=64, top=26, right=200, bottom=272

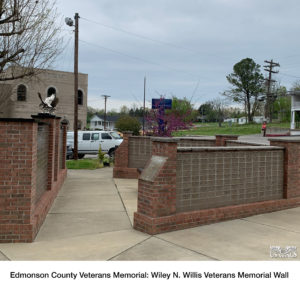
left=0, top=0, right=62, bottom=81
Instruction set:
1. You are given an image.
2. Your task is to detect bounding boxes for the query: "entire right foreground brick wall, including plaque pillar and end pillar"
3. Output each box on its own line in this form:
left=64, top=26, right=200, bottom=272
left=134, top=139, right=300, bottom=235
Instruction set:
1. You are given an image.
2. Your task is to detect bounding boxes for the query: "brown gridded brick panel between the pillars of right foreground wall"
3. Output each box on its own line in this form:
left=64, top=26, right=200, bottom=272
left=176, top=147, right=283, bottom=212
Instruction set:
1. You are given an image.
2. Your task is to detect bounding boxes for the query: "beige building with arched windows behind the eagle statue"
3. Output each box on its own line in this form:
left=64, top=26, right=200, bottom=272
left=0, top=70, right=88, bottom=130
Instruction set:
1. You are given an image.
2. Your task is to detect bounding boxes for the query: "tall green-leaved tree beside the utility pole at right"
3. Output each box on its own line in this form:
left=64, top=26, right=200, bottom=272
left=223, top=58, right=264, bottom=122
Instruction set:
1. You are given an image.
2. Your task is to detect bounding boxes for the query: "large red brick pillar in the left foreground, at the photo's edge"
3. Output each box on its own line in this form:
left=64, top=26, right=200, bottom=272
left=0, top=119, right=37, bottom=243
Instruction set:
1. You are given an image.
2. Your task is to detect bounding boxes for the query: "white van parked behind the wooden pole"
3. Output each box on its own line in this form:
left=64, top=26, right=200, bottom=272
left=67, top=130, right=123, bottom=158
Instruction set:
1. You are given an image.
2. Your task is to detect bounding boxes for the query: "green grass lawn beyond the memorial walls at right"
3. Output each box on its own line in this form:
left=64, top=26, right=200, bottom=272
left=173, top=123, right=290, bottom=136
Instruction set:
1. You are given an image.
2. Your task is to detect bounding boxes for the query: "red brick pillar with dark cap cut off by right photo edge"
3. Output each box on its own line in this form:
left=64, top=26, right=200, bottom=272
left=269, top=137, right=300, bottom=199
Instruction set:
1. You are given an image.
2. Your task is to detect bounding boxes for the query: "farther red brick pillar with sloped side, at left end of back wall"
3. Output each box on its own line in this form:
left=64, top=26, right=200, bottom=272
left=113, top=131, right=139, bottom=179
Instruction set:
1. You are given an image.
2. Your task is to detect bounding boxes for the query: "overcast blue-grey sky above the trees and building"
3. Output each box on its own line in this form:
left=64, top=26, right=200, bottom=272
left=53, top=0, right=300, bottom=111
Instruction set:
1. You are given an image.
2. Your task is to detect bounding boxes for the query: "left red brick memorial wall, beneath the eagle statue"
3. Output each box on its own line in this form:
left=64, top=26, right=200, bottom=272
left=0, top=116, right=66, bottom=243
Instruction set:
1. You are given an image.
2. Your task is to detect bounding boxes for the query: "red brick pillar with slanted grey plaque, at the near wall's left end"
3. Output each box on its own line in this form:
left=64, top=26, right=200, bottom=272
left=134, top=138, right=178, bottom=234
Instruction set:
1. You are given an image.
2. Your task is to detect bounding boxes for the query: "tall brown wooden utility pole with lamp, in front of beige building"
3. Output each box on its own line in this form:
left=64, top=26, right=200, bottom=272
left=65, top=13, right=80, bottom=160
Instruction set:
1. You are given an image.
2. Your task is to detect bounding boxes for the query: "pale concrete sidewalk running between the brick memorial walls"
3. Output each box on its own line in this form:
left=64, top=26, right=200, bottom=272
left=0, top=168, right=300, bottom=260
